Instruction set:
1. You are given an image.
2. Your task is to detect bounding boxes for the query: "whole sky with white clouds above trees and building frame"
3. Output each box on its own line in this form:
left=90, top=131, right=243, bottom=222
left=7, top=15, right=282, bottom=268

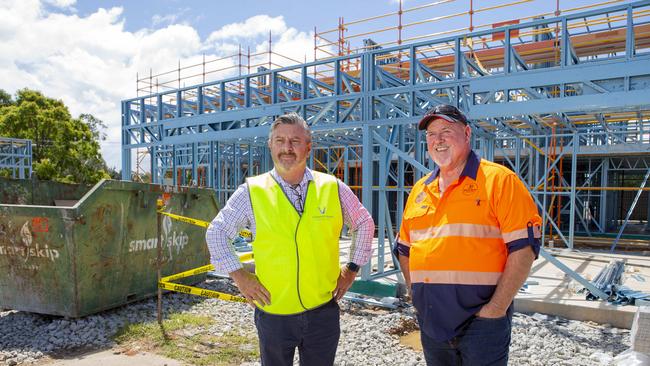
left=0, top=0, right=630, bottom=170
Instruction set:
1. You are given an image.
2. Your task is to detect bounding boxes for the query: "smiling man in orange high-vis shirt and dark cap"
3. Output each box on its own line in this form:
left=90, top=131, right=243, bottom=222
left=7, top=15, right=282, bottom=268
left=395, top=105, right=541, bottom=365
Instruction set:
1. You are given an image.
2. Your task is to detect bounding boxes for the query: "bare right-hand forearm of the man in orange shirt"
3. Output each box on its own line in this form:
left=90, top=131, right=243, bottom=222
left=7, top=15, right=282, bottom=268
left=476, top=246, right=535, bottom=318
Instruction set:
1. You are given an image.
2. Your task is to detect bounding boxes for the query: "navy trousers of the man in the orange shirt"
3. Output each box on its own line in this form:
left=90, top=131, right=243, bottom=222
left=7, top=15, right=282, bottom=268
left=420, top=315, right=512, bottom=366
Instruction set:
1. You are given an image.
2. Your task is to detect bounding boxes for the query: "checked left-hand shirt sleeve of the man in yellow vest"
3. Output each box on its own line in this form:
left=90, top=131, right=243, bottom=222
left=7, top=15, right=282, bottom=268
left=205, top=183, right=255, bottom=273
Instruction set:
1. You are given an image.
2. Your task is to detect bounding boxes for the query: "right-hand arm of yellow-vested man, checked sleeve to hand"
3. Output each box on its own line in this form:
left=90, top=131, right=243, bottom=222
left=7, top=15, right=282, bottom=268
left=332, top=181, right=375, bottom=300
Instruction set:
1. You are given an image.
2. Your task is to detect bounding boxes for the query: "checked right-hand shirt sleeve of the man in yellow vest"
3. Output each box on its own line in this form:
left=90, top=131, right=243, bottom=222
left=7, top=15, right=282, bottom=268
left=338, top=180, right=375, bottom=266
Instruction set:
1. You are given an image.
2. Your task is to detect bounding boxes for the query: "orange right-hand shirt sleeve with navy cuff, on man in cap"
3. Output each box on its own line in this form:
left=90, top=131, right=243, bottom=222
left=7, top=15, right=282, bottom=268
left=495, top=174, right=542, bottom=258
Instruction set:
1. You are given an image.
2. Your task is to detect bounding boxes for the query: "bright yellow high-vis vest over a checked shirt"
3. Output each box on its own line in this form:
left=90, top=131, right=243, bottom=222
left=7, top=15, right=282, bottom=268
left=247, top=171, right=343, bottom=315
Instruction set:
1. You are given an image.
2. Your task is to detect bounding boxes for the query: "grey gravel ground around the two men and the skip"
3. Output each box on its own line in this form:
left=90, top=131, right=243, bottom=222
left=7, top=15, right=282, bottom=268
left=0, top=279, right=630, bottom=366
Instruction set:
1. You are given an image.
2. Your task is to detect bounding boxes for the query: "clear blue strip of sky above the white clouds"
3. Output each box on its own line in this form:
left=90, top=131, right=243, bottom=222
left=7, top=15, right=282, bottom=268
left=63, top=0, right=631, bottom=41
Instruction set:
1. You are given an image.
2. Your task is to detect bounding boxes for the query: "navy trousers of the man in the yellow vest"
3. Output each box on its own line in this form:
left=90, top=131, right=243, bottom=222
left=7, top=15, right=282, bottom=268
left=255, top=299, right=341, bottom=366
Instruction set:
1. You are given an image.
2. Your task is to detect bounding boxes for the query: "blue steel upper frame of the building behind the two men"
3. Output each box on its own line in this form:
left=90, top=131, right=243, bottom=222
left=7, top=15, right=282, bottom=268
left=122, top=1, right=650, bottom=277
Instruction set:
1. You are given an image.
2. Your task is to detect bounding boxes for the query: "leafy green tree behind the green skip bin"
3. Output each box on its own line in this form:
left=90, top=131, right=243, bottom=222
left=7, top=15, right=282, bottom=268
left=0, top=89, right=110, bottom=184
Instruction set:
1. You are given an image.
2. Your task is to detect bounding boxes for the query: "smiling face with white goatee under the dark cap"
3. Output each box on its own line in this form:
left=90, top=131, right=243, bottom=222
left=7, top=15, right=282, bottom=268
left=426, top=118, right=472, bottom=170
